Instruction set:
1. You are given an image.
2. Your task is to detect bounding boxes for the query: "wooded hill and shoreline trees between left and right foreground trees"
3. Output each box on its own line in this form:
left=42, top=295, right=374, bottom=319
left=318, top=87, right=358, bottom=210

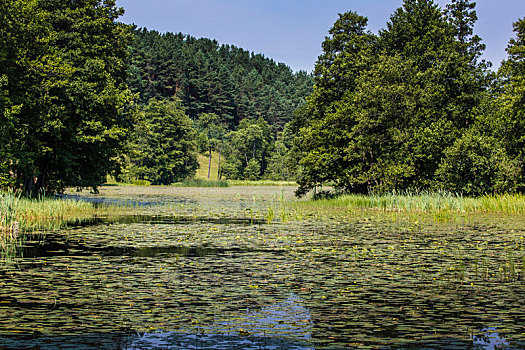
left=119, top=29, right=313, bottom=184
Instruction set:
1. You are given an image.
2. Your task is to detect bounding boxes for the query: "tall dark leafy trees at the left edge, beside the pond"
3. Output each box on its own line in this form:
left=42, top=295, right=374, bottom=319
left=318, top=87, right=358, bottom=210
left=0, top=0, right=131, bottom=194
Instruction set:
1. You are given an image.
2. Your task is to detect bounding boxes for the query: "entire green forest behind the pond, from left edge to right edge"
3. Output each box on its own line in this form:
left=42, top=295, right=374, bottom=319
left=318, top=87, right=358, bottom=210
left=0, top=0, right=525, bottom=196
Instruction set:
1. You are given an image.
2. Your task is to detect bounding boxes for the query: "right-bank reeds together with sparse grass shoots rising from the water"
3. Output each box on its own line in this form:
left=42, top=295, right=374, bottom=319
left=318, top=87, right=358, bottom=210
left=266, top=192, right=525, bottom=224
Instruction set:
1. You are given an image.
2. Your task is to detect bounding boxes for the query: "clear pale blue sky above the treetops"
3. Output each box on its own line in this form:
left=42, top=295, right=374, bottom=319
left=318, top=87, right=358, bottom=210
left=117, top=0, right=525, bottom=72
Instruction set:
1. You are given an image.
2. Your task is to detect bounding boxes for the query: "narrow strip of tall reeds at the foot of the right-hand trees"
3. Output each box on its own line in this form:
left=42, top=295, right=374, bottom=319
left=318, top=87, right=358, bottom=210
left=300, top=193, right=525, bottom=214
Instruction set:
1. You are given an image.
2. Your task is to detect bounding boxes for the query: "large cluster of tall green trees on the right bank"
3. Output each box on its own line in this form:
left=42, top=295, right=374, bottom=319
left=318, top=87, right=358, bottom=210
left=292, top=0, right=525, bottom=195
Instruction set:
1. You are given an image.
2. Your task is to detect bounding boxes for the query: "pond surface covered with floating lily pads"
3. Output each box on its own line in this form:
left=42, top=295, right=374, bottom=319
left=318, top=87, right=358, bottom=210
left=0, top=187, right=525, bottom=350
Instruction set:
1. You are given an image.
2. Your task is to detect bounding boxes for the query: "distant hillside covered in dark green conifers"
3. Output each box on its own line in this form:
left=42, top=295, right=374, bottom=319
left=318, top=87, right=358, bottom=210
left=128, top=29, right=313, bottom=130
